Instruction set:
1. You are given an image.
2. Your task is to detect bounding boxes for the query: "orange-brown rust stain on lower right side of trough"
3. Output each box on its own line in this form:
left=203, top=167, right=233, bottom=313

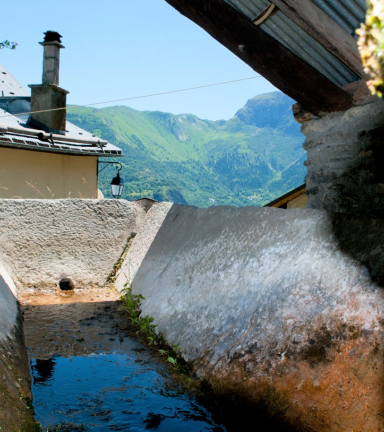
left=194, top=323, right=384, bottom=432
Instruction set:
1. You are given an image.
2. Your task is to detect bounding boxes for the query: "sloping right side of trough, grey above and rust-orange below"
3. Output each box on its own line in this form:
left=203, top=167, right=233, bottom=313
left=132, top=206, right=384, bottom=432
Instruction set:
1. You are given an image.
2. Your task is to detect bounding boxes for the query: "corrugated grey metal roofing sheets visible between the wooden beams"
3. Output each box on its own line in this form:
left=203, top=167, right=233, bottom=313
left=225, top=0, right=365, bottom=86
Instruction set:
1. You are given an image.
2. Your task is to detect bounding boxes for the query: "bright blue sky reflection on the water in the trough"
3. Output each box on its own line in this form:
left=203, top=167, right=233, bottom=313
left=32, top=354, right=224, bottom=432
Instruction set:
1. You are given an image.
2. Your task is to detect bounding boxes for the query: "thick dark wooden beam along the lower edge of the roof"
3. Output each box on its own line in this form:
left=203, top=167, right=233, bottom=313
left=166, top=0, right=351, bottom=115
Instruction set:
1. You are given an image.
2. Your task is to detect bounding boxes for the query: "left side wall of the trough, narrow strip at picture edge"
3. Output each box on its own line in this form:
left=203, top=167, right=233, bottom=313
left=0, top=263, right=35, bottom=432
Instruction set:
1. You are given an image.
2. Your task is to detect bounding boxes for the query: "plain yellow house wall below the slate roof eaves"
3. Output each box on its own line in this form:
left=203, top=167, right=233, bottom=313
left=0, top=148, right=97, bottom=199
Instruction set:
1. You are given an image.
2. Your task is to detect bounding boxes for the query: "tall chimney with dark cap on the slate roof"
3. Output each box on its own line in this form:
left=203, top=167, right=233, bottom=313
left=28, top=31, right=69, bottom=133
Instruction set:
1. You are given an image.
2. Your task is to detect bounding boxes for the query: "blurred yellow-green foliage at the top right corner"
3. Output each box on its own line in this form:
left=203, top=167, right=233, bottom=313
left=357, top=0, right=384, bottom=99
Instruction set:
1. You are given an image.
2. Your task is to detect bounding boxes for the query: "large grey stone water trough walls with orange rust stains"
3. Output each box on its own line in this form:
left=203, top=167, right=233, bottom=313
left=0, top=200, right=384, bottom=432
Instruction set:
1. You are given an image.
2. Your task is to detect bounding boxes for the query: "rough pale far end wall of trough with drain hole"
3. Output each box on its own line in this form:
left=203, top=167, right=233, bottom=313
left=0, top=199, right=145, bottom=288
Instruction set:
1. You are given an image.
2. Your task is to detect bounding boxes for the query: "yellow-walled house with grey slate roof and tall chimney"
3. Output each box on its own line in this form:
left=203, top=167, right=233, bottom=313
left=0, top=31, right=123, bottom=199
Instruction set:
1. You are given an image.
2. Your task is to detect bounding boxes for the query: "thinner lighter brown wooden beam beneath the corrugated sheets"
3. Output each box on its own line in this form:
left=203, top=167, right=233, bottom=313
left=272, top=0, right=365, bottom=77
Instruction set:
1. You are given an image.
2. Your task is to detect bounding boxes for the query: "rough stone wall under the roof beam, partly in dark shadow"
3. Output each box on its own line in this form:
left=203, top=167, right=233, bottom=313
left=302, top=100, right=384, bottom=217
